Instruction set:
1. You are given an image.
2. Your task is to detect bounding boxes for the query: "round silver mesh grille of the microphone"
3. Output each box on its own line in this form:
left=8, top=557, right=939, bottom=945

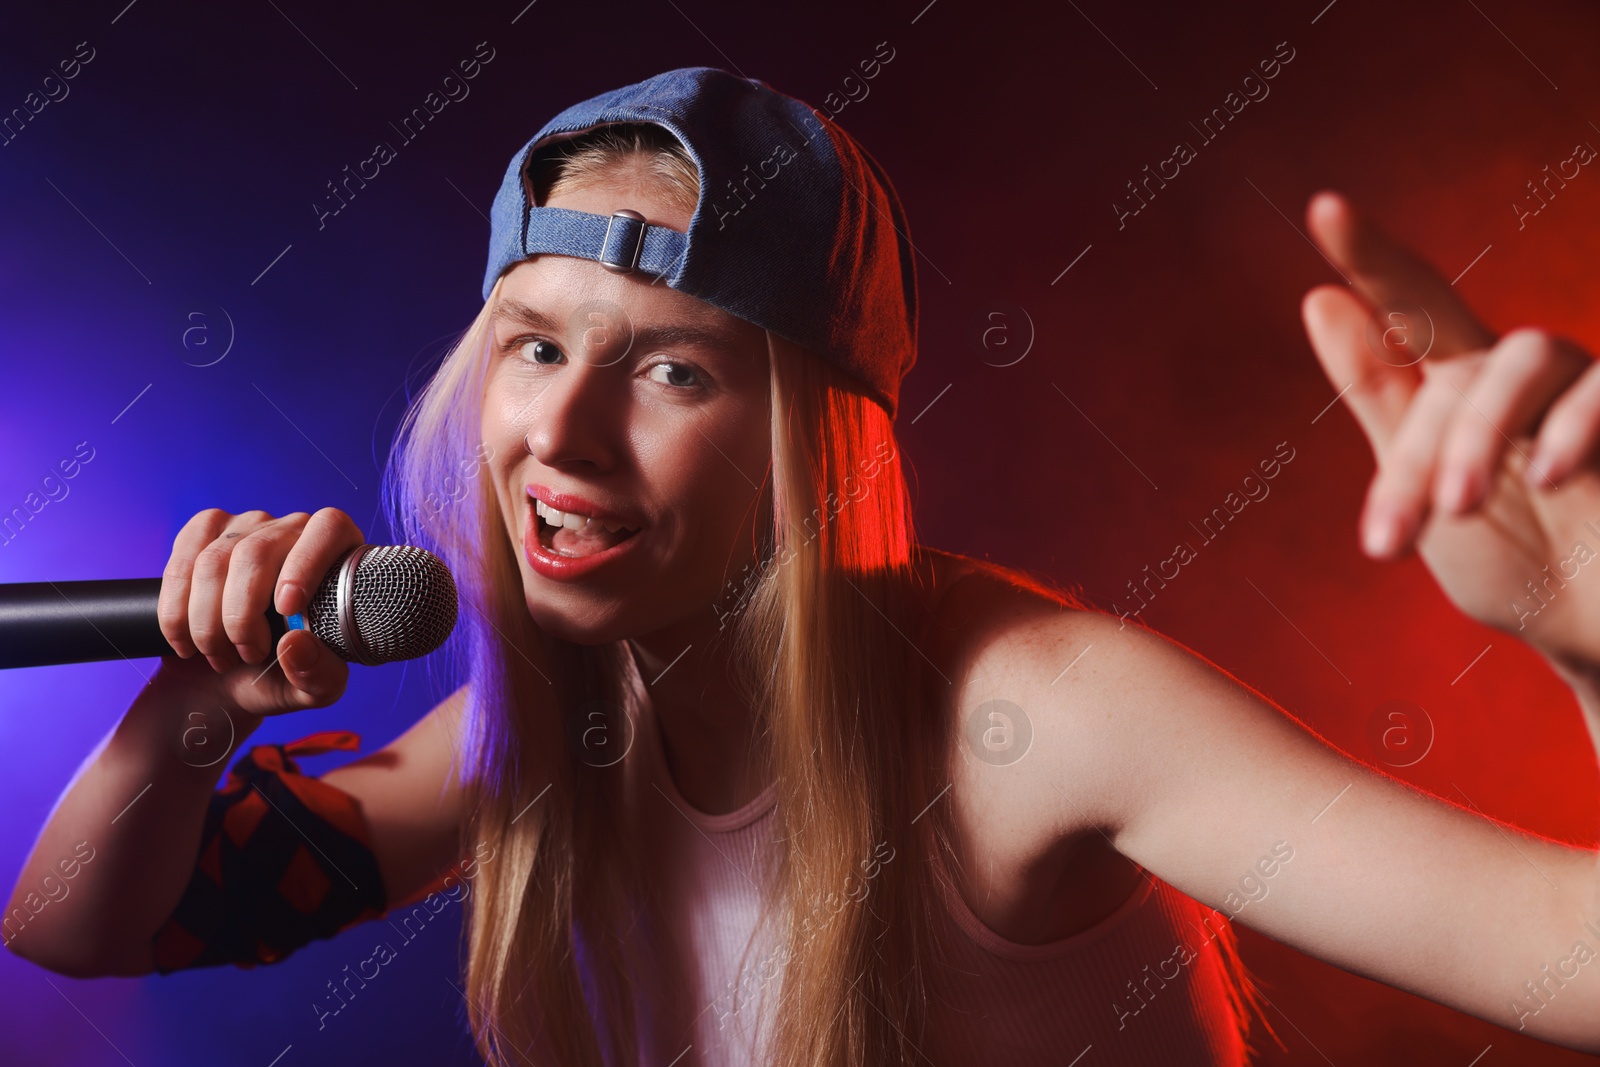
left=306, top=544, right=459, bottom=665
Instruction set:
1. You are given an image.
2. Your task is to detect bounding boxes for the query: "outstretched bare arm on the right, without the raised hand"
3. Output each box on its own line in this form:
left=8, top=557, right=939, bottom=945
left=962, top=591, right=1600, bottom=1051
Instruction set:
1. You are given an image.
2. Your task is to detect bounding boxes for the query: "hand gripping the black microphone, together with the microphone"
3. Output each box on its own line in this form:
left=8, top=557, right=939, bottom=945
left=0, top=507, right=458, bottom=715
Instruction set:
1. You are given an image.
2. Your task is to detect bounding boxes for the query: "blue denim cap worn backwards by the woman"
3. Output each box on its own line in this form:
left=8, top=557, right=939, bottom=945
left=483, top=67, right=917, bottom=418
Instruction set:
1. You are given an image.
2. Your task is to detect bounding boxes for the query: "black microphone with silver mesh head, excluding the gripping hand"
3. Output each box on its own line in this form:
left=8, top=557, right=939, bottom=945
left=0, top=544, right=458, bottom=669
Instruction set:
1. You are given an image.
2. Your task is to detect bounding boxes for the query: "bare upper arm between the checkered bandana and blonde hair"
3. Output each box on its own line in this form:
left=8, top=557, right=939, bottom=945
left=322, top=685, right=469, bottom=907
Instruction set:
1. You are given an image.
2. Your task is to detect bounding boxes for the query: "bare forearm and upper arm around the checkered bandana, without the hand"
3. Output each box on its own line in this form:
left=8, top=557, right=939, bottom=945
left=5, top=659, right=466, bottom=977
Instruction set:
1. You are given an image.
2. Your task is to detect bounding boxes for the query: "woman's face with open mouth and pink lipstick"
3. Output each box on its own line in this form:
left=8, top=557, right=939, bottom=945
left=483, top=176, right=771, bottom=645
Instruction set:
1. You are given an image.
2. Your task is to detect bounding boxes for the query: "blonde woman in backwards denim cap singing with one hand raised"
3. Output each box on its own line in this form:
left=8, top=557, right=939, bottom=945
left=8, top=69, right=1600, bottom=1067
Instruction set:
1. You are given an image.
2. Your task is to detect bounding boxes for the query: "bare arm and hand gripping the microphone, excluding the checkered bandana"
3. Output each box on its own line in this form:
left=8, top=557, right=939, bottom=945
left=0, top=509, right=462, bottom=976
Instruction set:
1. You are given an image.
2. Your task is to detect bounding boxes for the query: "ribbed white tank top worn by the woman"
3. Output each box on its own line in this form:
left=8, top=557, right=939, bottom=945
left=611, top=687, right=1245, bottom=1067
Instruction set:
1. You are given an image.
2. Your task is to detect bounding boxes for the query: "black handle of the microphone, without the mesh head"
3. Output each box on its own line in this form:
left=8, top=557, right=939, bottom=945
left=0, top=577, right=290, bottom=669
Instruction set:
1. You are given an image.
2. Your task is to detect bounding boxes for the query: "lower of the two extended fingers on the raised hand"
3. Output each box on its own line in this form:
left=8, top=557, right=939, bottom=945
left=1301, top=285, right=1422, bottom=464
